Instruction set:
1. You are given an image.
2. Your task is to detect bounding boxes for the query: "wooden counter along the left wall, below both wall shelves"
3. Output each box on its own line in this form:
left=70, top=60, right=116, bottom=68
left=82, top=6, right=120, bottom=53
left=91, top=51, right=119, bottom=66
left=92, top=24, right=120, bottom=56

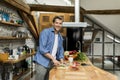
left=2, top=52, right=35, bottom=64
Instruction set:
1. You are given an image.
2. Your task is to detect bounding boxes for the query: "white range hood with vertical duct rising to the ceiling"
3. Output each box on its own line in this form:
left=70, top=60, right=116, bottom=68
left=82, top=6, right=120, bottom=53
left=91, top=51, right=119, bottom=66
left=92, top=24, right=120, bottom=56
left=62, top=0, right=89, bottom=28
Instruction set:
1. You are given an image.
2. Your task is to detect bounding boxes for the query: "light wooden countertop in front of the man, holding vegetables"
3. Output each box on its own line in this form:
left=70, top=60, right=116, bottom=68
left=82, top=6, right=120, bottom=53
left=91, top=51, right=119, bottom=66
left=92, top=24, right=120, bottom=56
left=49, top=60, right=118, bottom=80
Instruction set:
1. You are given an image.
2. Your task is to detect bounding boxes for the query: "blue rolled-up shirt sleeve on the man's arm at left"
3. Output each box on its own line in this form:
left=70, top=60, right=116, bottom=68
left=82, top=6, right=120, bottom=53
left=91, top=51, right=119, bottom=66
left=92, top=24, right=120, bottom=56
left=39, top=30, right=50, bottom=54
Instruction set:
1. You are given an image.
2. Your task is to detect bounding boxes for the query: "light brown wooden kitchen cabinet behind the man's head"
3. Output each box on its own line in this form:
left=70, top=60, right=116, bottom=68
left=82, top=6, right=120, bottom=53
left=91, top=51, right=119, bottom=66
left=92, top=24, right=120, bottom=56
left=39, top=13, right=69, bottom=37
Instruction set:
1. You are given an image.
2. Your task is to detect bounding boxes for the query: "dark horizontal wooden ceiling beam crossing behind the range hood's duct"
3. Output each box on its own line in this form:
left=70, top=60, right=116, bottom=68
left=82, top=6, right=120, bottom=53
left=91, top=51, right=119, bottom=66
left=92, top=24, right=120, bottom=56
left=29, top=4, right=120, bottom=15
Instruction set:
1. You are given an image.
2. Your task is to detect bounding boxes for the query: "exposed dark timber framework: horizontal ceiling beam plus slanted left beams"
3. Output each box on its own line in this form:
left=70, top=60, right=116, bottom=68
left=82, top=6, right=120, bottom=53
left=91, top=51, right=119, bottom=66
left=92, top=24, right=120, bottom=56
left=1, top=0, right=120, bottom=39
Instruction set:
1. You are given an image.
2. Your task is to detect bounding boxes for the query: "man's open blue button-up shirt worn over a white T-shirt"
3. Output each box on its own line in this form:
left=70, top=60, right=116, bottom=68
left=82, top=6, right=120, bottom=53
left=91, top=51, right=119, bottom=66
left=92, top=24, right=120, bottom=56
left=34, top=27, right=64, bottom=67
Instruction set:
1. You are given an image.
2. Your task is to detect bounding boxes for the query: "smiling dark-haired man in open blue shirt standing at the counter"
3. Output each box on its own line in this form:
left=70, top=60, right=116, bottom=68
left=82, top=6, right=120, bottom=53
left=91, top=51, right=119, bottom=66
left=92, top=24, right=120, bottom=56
left=34, top=16, right=64, bottom=80
